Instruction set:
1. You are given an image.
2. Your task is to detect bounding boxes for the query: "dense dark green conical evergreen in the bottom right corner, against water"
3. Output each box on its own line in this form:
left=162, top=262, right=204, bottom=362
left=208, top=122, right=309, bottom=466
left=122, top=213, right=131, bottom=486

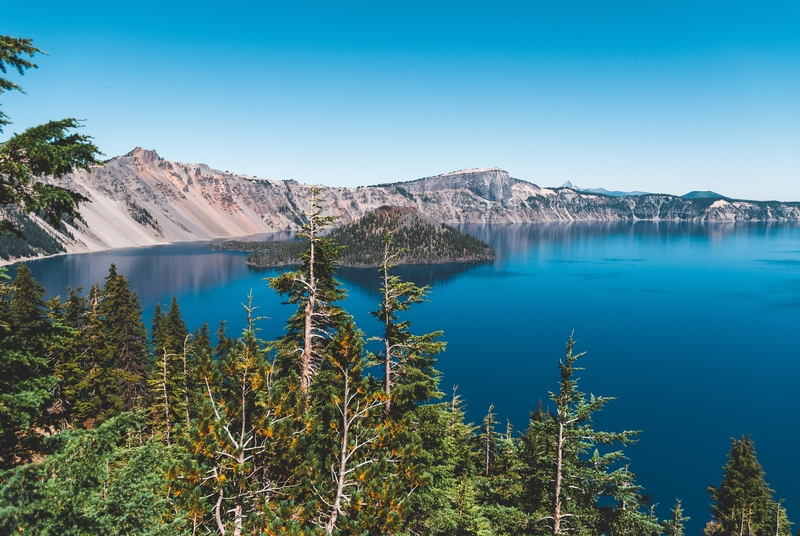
left=705, top=436, right=791, bottom=536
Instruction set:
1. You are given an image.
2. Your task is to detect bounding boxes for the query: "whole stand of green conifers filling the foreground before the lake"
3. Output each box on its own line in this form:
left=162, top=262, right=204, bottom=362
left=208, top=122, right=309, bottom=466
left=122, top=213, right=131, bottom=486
left=0, top=197, right=791, bottom=536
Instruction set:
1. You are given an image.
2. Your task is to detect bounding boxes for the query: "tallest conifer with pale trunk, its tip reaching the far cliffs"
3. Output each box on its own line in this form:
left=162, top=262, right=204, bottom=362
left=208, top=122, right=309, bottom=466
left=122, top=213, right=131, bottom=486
left=269, top=188, right=345, bottom=395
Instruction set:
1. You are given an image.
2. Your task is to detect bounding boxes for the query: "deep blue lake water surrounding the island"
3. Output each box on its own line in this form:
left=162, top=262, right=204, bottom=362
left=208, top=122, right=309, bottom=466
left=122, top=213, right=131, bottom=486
left=17, top=222, right=800, bottom=534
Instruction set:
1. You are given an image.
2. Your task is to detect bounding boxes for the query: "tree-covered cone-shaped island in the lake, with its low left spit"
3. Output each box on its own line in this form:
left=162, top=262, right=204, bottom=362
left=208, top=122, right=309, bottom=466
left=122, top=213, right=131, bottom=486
left=214, top=206, right=495, bottom=267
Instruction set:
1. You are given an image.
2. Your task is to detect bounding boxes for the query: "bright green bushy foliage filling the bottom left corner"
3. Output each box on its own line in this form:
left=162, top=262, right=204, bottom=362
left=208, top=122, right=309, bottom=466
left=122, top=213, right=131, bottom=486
left=0, top=413, right=189, bottom=536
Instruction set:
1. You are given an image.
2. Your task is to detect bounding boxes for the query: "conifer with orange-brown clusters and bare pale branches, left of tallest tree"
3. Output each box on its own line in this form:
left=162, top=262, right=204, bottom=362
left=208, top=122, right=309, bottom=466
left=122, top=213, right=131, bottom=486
left=191, top=294, right=291, bottom=536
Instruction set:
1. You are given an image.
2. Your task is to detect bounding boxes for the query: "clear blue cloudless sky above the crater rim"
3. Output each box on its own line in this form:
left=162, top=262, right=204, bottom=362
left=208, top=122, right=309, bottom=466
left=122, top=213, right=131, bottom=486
left=0, top=0, right=800, bottom=201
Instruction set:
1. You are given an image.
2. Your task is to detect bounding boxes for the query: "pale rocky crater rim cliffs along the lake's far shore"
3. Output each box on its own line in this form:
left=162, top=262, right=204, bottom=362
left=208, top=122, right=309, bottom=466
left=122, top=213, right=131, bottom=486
left=20, top=148, right=800, bottom=251
